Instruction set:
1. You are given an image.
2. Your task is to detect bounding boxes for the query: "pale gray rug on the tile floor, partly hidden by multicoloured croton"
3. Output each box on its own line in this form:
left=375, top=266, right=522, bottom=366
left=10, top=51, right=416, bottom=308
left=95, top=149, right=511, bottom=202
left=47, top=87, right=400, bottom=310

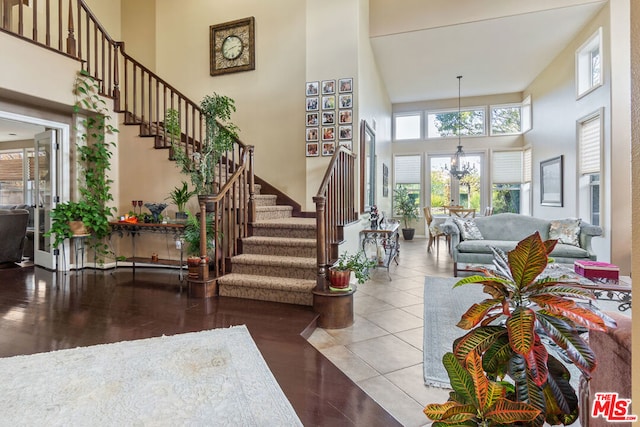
left=423, top=276, right=488, bottom=388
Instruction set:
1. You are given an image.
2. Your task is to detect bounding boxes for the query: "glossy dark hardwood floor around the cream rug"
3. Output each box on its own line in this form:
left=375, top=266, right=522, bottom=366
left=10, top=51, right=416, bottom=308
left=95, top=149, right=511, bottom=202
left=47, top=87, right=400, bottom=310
left=0, top=267, right=399, bottom=426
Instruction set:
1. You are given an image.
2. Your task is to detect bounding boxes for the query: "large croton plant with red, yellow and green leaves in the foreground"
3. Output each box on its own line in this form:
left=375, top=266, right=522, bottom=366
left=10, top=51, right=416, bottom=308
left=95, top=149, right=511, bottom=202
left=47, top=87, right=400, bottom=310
left=425, top=232, right=615, bottom=426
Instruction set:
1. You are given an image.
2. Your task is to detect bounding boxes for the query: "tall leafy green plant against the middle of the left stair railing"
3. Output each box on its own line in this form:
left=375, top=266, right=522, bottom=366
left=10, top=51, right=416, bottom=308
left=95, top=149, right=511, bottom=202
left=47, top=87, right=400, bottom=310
left=172, top=93, right=238, bottom=194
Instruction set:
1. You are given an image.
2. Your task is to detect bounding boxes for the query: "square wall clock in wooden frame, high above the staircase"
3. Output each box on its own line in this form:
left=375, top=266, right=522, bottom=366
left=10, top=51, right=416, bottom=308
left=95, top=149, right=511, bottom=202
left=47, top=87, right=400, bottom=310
left=209, top=16, right=256, bottom=76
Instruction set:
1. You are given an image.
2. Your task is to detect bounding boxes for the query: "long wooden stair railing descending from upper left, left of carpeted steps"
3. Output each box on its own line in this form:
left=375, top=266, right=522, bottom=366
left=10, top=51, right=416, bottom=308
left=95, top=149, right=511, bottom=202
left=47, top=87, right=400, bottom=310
left=0, top=0, right=255, bottom=271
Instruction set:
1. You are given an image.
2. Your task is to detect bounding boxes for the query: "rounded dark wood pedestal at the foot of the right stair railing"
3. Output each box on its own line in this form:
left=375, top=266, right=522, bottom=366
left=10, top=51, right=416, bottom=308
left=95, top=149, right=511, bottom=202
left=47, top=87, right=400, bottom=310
left=313, top=285, right=356, bottom=329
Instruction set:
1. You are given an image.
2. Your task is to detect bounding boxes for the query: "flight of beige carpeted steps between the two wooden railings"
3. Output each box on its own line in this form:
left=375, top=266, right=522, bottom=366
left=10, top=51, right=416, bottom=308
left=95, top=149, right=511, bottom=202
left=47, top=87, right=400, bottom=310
left=218, top=195, right=318, bottom=306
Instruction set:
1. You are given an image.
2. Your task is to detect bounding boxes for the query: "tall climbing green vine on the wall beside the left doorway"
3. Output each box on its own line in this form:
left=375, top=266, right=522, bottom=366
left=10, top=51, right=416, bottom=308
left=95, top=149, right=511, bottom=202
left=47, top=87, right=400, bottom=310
left=46, top=70, right=118, bottom=261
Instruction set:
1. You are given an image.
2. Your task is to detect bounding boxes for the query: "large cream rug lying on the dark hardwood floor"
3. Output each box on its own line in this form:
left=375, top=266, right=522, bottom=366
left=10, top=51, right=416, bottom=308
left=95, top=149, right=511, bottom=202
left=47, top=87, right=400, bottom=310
left=0, top=326, right=302, bottom=427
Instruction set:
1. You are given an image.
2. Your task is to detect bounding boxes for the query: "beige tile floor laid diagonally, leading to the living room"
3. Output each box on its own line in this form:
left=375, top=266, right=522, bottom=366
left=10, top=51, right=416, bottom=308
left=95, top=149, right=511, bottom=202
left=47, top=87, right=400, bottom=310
left=309, top=238, right=631, bottom=427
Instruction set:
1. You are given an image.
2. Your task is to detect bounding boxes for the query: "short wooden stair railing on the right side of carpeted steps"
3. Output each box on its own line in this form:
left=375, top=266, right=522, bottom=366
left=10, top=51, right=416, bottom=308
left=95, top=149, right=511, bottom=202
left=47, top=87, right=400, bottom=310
left=313, top=146, right=358, bottom=291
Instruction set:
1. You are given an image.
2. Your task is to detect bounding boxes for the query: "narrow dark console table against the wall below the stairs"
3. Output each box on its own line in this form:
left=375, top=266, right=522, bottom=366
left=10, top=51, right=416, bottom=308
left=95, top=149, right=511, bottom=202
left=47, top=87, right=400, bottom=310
left=109, top=221, right=184, bottom=281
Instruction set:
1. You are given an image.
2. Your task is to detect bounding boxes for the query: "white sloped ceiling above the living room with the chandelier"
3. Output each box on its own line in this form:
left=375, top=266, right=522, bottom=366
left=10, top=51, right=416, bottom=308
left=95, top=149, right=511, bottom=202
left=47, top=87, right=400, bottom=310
left=370, top=0, right=606, bottom=103
